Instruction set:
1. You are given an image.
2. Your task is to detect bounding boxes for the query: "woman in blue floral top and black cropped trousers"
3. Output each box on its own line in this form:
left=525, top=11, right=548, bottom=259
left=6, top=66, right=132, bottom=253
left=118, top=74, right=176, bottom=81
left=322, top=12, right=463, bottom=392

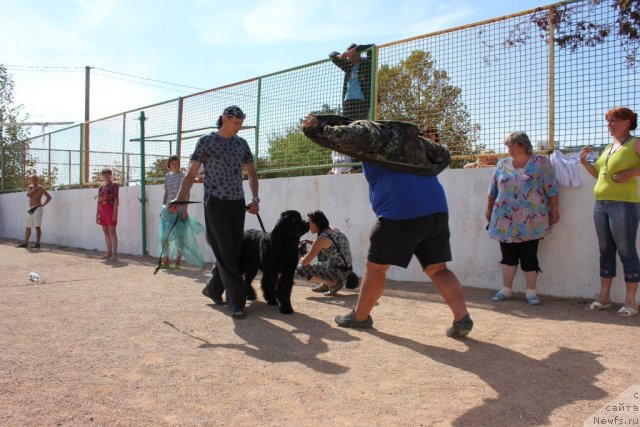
left=485, top=132, right=560, bottom=305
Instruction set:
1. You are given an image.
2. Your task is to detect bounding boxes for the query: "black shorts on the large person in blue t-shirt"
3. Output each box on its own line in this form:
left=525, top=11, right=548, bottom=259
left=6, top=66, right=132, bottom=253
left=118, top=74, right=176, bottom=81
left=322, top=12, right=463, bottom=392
left=367, top=212, right=451, bottom=269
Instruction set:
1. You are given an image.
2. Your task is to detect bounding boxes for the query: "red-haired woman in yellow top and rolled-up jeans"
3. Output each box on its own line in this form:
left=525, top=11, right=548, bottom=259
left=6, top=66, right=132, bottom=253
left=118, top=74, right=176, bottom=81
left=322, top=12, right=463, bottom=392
left=580, top=107, right=640, bottom=317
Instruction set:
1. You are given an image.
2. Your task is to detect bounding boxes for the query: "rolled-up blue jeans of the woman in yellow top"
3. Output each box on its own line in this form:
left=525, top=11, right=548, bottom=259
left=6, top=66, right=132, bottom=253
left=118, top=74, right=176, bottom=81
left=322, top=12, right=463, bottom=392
left=593, top=200, right=640, bottom=283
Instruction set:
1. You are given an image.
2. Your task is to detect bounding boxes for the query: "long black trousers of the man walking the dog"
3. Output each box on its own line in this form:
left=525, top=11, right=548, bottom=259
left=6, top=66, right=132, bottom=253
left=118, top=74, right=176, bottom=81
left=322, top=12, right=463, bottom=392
left=204, top=196, right=247, bottom=311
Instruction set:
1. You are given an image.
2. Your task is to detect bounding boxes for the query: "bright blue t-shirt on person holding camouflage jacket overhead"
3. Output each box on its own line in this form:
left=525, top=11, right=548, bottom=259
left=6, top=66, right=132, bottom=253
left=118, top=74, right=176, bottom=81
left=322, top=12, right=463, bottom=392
left=362, top=162, right=448, bottom=220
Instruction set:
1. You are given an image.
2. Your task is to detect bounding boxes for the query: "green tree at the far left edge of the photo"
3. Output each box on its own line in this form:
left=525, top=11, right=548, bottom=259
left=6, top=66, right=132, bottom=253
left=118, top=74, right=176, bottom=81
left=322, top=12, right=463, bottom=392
left=0, top=64, right=35, bottom=190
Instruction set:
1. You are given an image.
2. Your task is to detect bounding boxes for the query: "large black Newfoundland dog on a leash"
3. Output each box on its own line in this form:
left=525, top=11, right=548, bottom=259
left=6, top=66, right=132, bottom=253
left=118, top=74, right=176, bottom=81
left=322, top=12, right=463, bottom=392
left=240, top=211, right=309, bottom=314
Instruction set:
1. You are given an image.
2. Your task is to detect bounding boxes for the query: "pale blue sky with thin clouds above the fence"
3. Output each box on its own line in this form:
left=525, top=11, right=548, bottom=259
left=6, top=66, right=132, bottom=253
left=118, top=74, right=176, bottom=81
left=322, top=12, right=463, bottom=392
left=0, top=0, right=550, bottom=130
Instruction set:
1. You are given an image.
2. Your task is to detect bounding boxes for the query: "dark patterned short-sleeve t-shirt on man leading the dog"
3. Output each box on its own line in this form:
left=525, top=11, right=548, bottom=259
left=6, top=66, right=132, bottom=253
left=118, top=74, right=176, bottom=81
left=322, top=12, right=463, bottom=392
left=191, top=132, right=253, bottom=200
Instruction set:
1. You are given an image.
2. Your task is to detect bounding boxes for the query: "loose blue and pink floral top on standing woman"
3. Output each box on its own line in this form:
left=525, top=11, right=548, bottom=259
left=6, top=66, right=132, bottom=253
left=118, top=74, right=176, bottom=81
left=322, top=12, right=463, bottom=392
left=489, top=154, right=560, bottom=243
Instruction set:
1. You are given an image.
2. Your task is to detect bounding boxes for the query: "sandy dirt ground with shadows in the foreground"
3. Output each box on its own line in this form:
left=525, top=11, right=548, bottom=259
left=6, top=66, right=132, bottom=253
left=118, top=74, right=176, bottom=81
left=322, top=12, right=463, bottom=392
left=0, top=240, right=640, bottom=426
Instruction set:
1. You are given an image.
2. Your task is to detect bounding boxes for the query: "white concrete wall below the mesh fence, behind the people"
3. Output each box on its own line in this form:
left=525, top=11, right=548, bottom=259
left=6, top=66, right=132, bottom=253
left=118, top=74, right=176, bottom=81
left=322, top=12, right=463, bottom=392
left=0, top=169, right=636, bottom=302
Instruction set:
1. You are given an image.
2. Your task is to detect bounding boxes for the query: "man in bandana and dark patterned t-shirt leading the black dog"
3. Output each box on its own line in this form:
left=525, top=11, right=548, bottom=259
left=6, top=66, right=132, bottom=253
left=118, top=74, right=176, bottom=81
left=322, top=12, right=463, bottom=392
left=175, top=105, right=260, bottom=319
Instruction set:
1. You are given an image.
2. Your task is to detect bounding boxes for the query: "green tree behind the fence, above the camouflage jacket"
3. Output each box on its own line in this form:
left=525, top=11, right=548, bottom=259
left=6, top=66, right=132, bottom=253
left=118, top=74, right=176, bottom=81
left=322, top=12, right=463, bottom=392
left=378, top=50, right=480, bottom=166
